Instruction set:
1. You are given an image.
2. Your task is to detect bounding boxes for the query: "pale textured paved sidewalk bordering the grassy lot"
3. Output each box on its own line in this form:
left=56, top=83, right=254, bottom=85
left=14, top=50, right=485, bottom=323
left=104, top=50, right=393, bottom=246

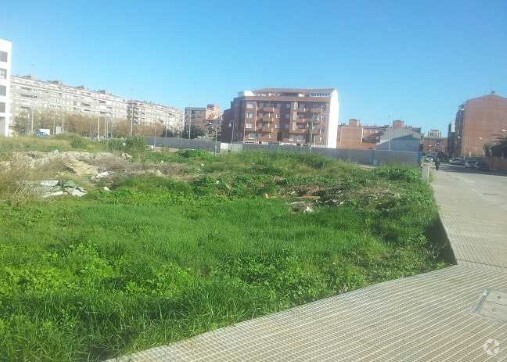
left=117, top=168, right=507, bottom=361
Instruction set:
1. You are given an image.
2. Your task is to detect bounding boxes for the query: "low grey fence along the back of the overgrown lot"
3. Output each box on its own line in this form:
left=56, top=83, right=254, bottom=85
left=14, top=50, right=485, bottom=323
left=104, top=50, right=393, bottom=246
left=147, top=137, right=421, bottom=166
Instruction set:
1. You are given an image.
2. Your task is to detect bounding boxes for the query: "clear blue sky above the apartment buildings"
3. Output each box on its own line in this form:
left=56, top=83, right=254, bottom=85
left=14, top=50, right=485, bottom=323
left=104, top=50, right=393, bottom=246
left=0, top=0, right=507, bottom=133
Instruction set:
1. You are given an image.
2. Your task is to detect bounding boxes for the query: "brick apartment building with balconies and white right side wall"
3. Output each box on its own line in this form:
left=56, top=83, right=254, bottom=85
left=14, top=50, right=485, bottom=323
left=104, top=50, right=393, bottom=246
left=222, top=88, right=339, bottom=148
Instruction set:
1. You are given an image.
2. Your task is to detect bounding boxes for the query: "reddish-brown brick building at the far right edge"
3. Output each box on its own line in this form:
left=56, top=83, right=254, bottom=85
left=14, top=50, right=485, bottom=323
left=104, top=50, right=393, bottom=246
left=448, top=92, right=507, bottom=157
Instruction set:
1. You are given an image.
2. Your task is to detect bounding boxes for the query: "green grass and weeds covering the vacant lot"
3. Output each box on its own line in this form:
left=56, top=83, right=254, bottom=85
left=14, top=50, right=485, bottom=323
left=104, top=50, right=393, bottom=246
left=0, top=146, right=445, bottom=361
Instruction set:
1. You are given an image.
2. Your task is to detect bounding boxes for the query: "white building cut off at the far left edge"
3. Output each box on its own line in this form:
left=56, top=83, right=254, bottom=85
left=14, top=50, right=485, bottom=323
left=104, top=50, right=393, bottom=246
left=0, top=39, right=12, bottom=137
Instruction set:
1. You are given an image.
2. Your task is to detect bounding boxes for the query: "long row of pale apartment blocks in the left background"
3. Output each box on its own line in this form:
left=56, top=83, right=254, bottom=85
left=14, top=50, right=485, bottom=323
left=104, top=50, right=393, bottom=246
left=11, top=76, right=183, bottom=132
